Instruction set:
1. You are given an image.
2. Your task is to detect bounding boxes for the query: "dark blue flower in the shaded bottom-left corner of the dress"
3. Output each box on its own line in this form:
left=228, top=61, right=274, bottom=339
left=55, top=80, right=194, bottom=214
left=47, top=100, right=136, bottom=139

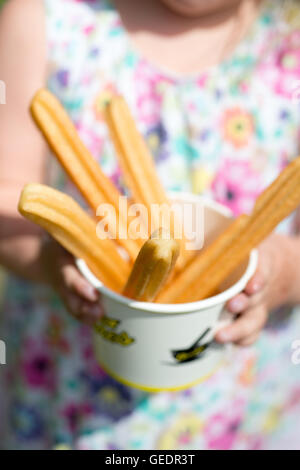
left=10, top=402, right=44, bottom=441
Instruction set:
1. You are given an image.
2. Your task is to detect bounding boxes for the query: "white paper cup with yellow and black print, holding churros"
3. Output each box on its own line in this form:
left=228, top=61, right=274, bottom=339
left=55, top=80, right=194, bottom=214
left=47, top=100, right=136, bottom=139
left=77, top=194, right=257, bottom=392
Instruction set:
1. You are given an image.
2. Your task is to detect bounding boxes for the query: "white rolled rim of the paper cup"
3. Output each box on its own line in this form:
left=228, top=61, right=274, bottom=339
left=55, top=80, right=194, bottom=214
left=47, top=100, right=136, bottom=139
left=75, top=192, right=258, bottom=314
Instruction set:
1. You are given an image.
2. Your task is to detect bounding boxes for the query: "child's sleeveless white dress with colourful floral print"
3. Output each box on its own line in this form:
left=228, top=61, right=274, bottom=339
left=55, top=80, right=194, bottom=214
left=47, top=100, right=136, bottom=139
left=0, top=0, right=300, bottom=449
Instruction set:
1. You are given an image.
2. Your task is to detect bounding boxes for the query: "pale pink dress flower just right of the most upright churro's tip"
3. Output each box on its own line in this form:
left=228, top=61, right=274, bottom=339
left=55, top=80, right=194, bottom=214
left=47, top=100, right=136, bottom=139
left=134, top=60, right=171, bottom=126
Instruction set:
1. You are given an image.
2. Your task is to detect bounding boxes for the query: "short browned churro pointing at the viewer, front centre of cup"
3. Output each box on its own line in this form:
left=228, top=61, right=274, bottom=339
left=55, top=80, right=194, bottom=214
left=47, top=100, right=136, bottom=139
left=123, top=229, right=179, bottom=302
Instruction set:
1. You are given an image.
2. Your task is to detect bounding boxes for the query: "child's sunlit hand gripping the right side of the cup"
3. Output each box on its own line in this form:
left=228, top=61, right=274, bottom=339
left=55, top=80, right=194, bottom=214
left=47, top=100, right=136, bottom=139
left=216, top=234, right=298, bottom=346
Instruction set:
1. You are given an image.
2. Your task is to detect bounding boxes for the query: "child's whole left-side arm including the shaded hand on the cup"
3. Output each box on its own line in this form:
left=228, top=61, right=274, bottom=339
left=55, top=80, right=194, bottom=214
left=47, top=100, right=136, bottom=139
left=0, top=0, right=102, bottom=324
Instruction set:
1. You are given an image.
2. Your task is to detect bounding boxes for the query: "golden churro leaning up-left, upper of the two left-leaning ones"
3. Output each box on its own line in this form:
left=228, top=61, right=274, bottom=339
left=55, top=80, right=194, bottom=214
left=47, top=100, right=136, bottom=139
left=30, top=89, right=143, bottom=260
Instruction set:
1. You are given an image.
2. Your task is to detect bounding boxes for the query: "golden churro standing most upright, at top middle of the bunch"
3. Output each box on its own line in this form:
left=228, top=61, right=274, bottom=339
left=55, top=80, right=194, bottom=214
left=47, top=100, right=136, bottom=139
left=104, top=96, right=192, bottom=268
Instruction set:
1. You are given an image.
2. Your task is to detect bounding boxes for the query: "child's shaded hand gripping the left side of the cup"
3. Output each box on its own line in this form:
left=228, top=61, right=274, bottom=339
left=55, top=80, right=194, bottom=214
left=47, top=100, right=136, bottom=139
left=41, top=238, right=103, bottom=326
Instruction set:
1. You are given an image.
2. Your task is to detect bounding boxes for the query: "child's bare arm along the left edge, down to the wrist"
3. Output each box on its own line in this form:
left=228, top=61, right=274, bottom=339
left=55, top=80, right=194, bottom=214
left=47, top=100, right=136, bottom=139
left=0, top=0, right=46, bottom=280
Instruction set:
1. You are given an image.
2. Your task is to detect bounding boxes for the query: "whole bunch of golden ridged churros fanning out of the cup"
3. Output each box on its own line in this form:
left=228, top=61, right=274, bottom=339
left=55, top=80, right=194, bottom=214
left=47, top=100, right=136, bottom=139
left=19, top=89, right=300, bottom=303
